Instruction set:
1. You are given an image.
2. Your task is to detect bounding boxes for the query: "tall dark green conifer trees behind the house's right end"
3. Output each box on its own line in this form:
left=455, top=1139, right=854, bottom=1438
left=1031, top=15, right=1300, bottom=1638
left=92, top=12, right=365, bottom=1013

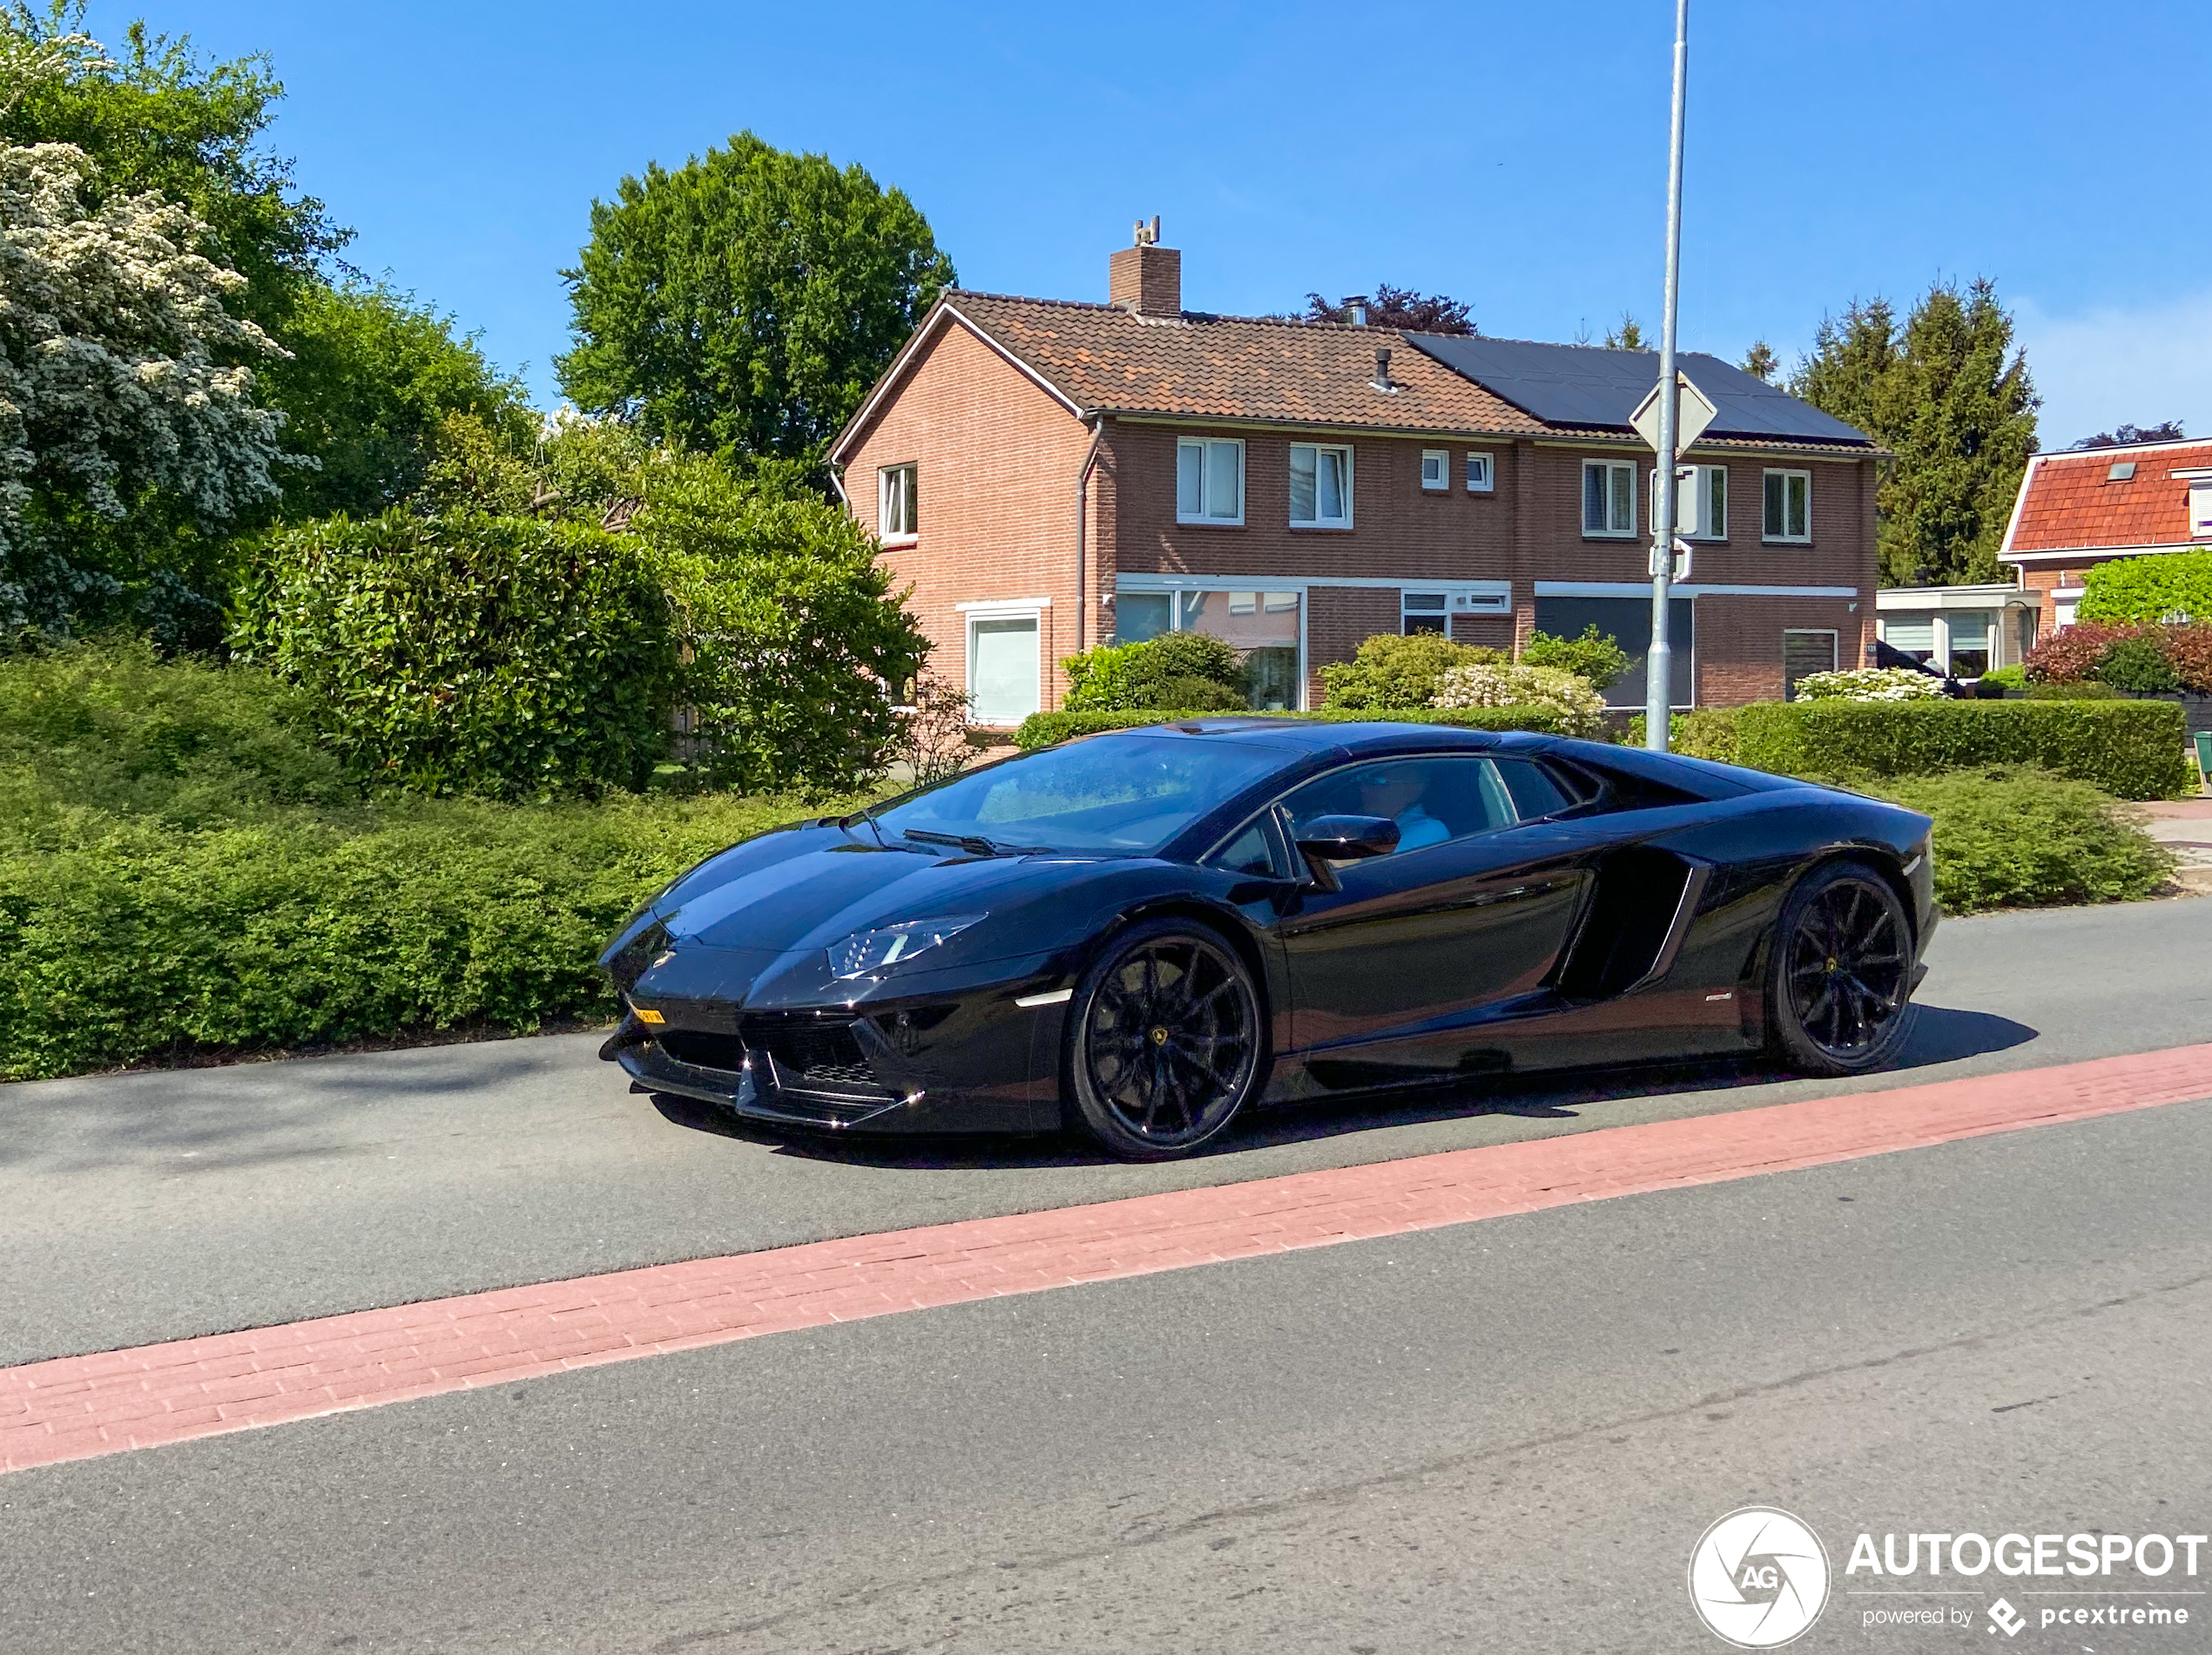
left=1790, top=277, right=2041, bottom=586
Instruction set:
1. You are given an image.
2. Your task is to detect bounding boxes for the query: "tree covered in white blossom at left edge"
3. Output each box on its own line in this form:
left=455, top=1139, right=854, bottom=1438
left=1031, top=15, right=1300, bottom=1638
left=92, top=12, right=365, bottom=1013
left=0, top=144, right=283, bottom=562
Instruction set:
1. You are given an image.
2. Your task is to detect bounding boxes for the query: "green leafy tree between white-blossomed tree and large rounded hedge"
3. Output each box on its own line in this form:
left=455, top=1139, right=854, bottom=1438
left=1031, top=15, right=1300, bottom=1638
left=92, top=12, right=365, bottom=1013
left=263, top=283, right=537, bottom=520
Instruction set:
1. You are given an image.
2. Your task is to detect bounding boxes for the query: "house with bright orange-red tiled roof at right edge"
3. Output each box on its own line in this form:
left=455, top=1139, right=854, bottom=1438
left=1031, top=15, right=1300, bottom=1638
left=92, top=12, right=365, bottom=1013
left=1998, top=442, right=2212, bottom=635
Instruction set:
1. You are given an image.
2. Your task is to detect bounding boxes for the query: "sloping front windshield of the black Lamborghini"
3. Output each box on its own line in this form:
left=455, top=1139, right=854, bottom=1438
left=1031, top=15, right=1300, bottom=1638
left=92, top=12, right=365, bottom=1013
left=876, top=737, right=1290, bottom=856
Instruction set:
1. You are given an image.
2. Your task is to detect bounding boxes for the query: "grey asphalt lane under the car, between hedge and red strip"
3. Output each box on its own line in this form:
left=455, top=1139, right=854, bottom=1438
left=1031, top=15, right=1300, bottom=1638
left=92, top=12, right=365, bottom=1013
left=0, top=901, right=2212, bottom=1363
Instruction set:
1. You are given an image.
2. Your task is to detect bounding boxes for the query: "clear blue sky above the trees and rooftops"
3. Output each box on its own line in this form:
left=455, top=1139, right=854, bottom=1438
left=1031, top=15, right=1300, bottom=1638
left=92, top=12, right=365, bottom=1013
left=133, top=0, right=2212, bottom=445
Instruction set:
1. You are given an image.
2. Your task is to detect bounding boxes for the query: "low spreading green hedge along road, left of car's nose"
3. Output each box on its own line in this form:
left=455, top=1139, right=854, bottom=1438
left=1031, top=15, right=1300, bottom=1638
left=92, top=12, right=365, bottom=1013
left=0, top=796, right=853, bottom=1080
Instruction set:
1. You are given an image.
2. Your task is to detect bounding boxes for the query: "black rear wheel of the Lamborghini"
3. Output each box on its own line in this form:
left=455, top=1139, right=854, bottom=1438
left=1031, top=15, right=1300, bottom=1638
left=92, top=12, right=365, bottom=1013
left=1767, top=863, right=1913, bottom=1075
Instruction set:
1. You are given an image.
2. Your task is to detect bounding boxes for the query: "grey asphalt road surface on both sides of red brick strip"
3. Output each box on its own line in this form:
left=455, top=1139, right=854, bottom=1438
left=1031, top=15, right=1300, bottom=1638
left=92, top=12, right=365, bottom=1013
left=0, top=902, right=2212, bottom=1655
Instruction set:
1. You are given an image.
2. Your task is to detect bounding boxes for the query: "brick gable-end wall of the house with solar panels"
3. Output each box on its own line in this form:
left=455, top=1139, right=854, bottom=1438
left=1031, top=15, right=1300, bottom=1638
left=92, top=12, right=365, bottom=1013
left=845, top=323, right=1092, bottom=708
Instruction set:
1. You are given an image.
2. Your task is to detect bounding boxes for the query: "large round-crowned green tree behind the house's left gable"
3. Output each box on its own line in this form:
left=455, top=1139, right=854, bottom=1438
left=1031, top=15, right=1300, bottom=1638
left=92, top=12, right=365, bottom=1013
left=556, top=132, right=954, bottom=463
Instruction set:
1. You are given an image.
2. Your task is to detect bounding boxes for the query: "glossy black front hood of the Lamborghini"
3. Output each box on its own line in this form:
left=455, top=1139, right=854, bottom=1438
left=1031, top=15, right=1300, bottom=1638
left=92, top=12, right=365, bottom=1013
left=651, top=823, right=1128, bottom=954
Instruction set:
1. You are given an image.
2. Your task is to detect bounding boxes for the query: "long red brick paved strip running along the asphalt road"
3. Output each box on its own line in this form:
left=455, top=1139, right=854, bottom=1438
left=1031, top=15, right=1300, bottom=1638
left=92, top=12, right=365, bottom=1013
left=0, top=1046, right=2212, bottom=1471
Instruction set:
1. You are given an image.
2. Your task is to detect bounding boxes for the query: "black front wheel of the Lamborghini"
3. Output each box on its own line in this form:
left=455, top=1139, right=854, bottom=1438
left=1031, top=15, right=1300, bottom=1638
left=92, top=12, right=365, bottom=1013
left=1066, top=921, right=1265, bottom=1162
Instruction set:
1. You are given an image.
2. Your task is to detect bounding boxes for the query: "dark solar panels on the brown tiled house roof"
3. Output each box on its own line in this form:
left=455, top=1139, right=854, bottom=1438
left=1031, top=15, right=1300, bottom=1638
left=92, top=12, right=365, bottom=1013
left=1406, top=334, right=1871, bottom=442
